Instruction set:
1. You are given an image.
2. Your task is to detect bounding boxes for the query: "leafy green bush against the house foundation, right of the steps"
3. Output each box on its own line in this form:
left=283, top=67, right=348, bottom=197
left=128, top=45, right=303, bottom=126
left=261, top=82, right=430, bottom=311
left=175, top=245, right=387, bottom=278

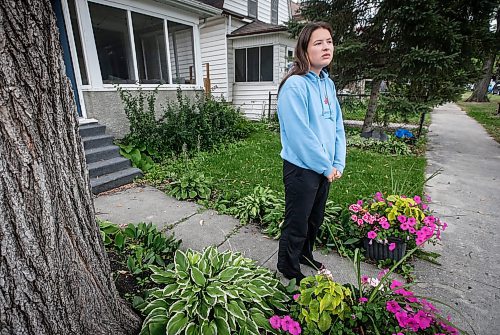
left=119, top=89, right=253, bottom=161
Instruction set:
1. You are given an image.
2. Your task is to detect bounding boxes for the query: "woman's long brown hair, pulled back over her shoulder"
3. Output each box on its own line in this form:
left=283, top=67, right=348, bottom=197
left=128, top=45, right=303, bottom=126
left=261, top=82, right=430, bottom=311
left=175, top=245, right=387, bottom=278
left=278, top=22, right=332, bottom=92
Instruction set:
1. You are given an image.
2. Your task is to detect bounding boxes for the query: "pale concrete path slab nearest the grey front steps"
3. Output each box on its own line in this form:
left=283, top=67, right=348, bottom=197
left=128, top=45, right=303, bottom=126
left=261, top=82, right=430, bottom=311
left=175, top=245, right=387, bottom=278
left=94, top=186, right=202, bottom=229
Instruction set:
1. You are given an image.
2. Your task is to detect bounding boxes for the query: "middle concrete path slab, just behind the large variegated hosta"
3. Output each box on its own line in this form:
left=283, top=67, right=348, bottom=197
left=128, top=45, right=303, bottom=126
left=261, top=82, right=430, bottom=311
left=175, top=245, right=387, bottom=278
left=167, top=210, right=240, bottom=251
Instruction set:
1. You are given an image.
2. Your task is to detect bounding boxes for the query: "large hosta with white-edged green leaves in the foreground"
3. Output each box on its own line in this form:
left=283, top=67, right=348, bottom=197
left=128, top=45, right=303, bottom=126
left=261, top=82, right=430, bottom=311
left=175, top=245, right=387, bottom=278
left=141, top=247, right=290, bottom=335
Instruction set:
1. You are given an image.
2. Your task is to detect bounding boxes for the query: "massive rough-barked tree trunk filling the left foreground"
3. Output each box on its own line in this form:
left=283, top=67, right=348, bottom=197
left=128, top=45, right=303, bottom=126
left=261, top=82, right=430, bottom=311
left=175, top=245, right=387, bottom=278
left=0, top=0, right=140, bottom=335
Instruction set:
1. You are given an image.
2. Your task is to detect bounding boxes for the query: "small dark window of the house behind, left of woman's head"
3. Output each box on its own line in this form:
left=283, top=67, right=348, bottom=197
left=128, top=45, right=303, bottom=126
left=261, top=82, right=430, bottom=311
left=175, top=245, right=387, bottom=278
left=235, top=45, right=273, bottom=82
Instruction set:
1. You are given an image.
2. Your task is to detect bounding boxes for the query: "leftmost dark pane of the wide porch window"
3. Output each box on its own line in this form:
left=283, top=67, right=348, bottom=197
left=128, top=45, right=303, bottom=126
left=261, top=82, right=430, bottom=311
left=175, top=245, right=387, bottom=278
left=89, top=2, right=135, bottom=84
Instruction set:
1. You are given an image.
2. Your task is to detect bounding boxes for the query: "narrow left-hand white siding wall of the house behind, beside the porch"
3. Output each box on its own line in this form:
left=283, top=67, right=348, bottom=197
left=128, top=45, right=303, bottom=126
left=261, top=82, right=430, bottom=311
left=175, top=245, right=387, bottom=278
left=200, top=17, right=229, bottom=99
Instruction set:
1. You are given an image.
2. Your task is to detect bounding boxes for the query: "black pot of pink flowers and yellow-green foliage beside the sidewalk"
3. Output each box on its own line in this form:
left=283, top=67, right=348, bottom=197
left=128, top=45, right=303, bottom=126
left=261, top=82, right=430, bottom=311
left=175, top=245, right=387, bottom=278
left=349, top=192, right=447, bottom=261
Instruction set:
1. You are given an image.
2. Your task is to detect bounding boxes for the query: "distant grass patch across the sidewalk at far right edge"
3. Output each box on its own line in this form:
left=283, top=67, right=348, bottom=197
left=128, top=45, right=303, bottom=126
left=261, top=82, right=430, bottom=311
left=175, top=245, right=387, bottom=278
left=457, top=93, right=500, bottom=143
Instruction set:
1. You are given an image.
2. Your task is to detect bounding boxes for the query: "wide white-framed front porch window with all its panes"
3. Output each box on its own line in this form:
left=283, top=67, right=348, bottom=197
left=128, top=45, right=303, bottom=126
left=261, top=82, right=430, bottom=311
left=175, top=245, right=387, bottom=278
left=84, top=0, right=196, bottom=84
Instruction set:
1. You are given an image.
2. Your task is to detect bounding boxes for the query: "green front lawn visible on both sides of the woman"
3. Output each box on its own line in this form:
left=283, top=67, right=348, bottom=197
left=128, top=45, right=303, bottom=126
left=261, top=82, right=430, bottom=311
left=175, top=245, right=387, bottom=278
left=176, top=130, right=426, bottom=204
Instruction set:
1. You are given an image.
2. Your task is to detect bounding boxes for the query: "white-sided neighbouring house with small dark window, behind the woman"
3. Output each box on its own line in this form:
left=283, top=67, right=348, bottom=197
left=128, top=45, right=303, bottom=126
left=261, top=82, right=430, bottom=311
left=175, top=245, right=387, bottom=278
left=199, top=0, right=296, bottom=119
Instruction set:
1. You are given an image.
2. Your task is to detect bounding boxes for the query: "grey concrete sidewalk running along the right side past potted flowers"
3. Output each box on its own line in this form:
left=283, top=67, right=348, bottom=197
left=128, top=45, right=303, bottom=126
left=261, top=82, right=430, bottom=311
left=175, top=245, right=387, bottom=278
left=415, top=104, right=500, bottom=335
